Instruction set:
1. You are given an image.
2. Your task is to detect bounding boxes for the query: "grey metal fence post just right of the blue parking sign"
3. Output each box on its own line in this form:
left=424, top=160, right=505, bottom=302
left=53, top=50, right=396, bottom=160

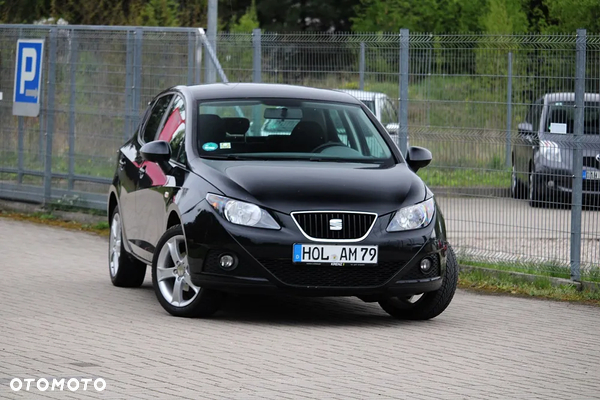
left=44, top=28, right=57, bottom=205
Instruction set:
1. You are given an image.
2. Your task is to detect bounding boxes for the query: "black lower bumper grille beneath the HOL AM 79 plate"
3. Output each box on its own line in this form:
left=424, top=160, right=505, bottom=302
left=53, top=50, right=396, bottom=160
left=259, top=259, right=402, bottom=287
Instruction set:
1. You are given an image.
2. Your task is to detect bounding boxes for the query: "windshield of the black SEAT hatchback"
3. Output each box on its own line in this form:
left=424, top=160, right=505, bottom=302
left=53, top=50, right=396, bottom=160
left=196, top=99, right=393, bottom=164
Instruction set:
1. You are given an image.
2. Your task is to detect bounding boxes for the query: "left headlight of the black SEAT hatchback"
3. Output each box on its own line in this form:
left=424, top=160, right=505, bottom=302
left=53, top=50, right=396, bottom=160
left=206, top=193, right=280, bottom=229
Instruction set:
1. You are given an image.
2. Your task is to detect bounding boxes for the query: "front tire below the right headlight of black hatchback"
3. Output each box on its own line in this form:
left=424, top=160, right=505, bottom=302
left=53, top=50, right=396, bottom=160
left=379, top=247, right=458, bottom=320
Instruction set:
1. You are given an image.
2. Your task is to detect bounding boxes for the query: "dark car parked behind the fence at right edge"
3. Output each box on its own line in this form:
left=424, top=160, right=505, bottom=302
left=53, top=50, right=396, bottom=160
left=511, top=93, right=600, bottom=207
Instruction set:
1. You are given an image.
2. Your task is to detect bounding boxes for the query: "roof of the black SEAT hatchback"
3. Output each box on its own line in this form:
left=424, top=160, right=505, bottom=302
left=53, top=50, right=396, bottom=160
left=176, top=83, right=360, bottom=104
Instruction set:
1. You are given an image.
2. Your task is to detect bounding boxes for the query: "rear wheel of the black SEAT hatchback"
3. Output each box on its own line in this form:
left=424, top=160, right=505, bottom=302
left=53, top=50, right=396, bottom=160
left=108, top=206, right=146, bottom=287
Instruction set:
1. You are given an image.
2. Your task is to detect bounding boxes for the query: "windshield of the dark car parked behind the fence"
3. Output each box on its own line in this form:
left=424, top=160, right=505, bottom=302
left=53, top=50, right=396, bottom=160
left=544, top=101, right=600, bottom=135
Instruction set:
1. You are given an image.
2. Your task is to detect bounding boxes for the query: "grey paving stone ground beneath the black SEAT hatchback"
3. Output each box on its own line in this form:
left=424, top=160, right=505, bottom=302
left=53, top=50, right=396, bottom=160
left=0, top=218, right=600, bottom=400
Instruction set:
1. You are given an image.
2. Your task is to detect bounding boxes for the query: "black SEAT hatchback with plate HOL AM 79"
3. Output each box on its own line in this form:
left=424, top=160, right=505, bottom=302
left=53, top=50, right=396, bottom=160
left=108, top=83, right=458, bottom=319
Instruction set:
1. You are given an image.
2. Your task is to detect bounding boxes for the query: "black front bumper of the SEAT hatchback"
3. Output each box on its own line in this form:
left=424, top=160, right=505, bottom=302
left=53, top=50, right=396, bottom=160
left=184, top=201, right=447, bottom=296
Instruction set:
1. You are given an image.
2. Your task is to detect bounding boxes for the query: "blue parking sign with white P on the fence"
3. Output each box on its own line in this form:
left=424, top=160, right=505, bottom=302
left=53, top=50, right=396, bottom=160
left=13, top=39, right=44, bottom=117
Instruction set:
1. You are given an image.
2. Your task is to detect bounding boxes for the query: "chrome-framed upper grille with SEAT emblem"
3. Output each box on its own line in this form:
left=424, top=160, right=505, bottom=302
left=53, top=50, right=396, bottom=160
left=292, top=212, right=377, bottom=240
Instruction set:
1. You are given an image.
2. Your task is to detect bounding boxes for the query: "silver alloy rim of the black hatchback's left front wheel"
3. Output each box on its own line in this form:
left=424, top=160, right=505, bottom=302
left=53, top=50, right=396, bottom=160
left=156, top=235, right=200, bottom=307
